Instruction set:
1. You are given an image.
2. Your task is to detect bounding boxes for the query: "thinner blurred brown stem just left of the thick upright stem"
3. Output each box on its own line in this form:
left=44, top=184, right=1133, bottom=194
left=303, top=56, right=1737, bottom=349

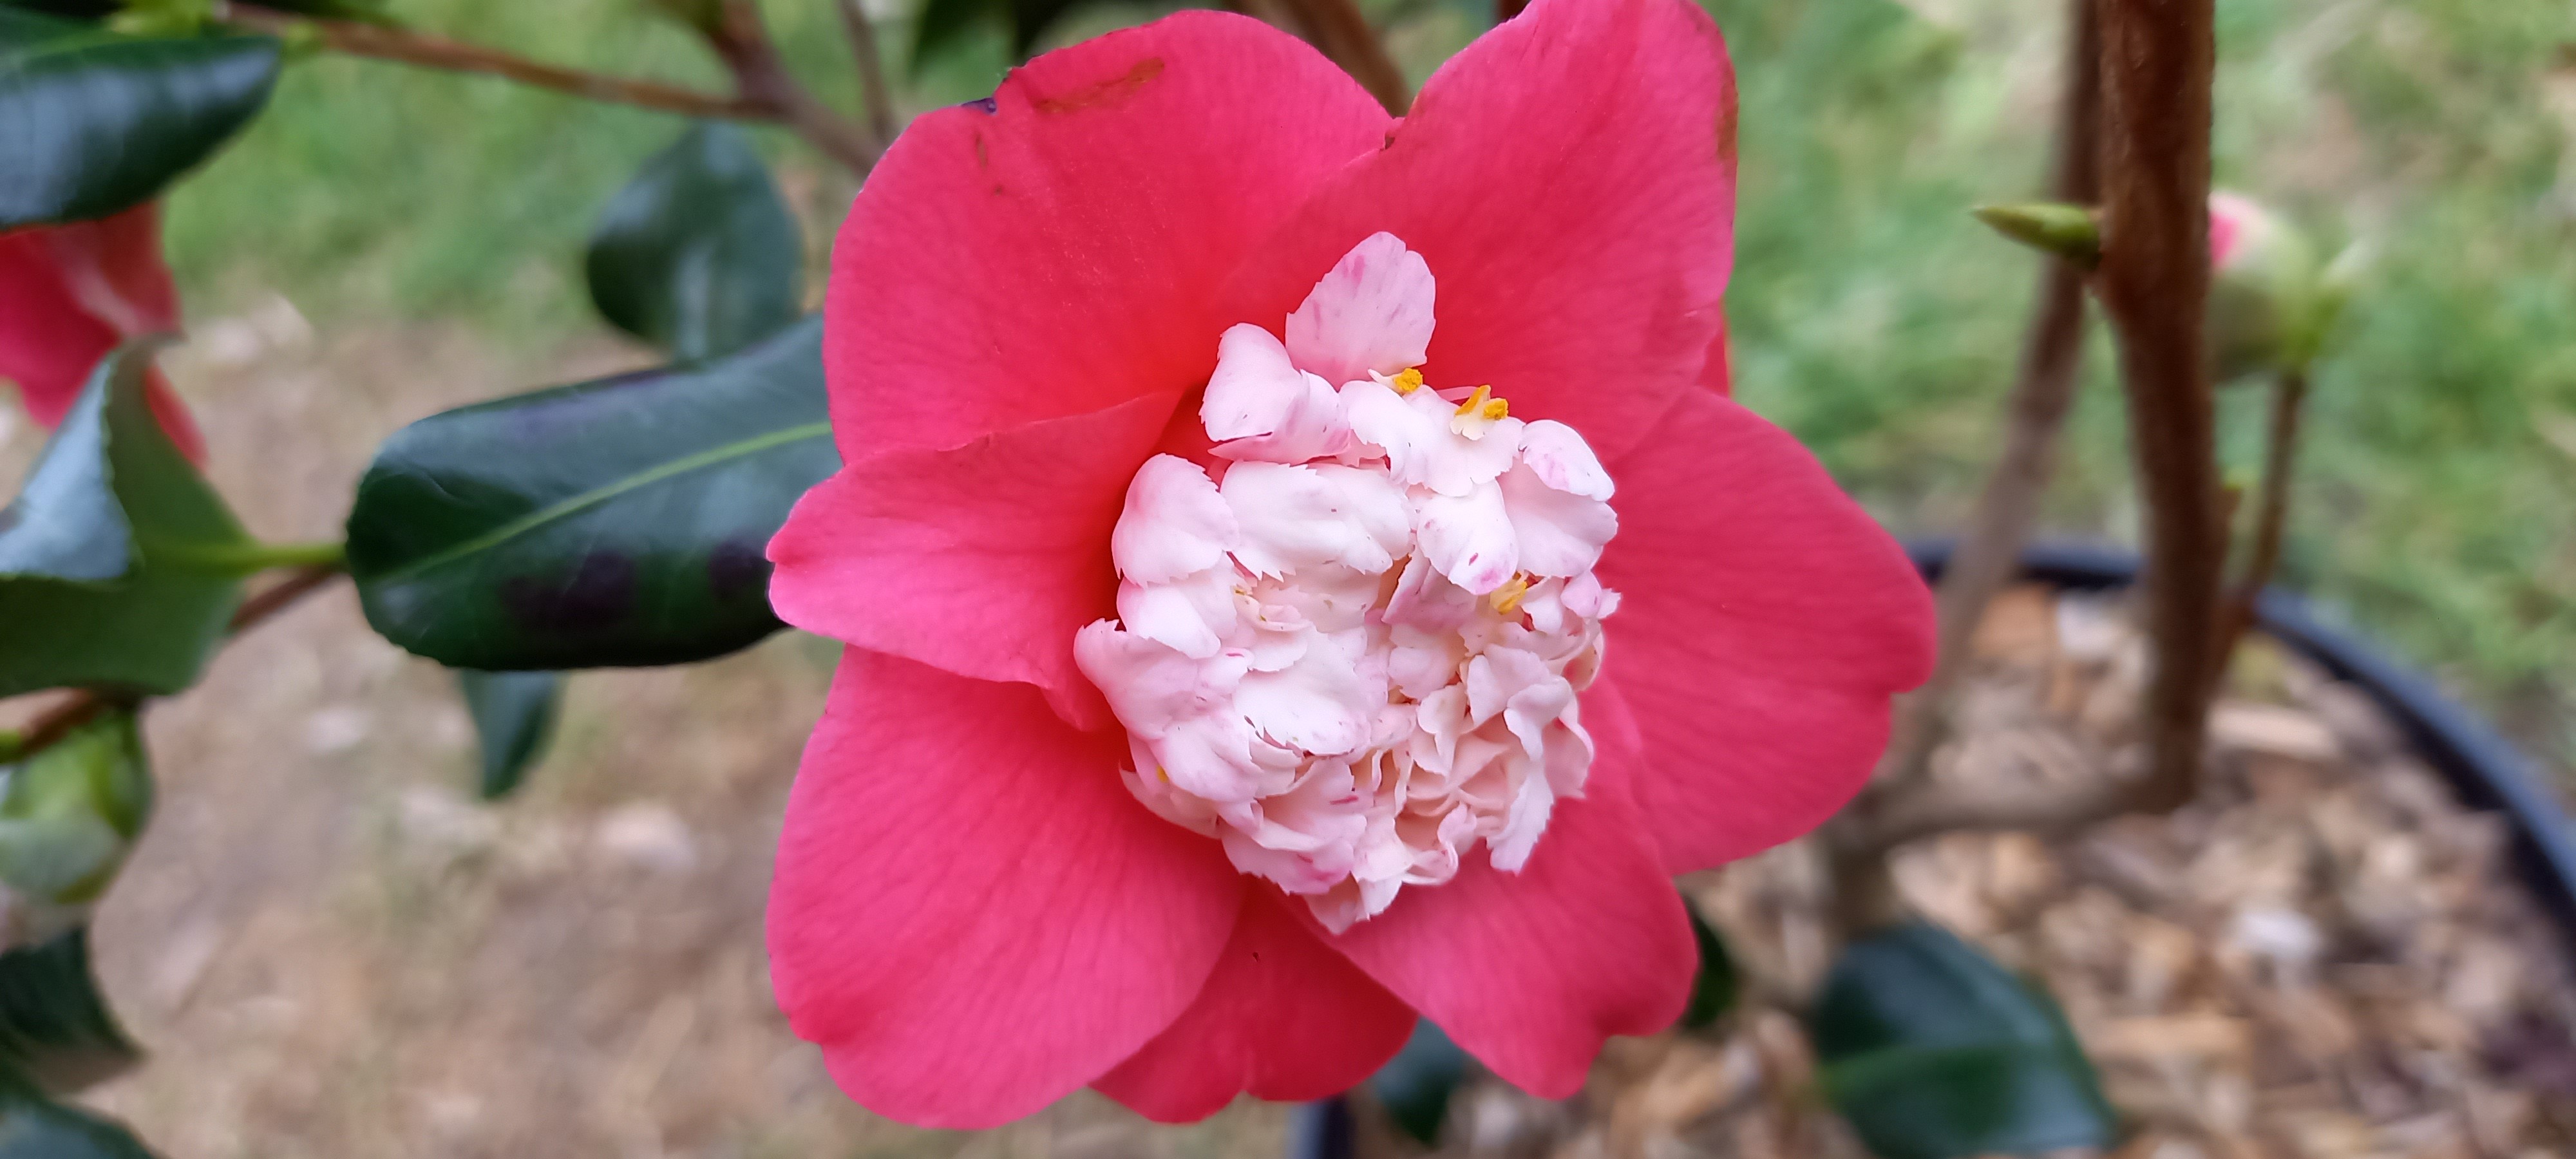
left=1873, top=0, right=2102, bottom=786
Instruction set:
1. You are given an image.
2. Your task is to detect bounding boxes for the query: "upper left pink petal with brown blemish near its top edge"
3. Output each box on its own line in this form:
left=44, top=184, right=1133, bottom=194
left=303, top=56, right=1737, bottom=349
left=824, top=13, right=1388, bottom=458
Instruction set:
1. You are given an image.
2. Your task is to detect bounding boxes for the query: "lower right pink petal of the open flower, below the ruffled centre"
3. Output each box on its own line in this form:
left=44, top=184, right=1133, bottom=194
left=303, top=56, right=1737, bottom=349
left=1327, top=768, right=1700, bottom=1100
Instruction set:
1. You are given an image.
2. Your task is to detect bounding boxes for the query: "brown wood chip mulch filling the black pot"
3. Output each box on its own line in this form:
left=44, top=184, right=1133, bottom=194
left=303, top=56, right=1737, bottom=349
left=1391, top=587, right=2576, bottom=1159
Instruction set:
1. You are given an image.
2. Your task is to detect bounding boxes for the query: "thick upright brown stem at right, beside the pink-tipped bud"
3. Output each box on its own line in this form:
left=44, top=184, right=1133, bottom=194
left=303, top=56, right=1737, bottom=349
left=2094, top=0, right=2226, bottom=809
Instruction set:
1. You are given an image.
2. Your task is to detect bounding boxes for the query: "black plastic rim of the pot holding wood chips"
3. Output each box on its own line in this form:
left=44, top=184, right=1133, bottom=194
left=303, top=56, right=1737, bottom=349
left=1288, top=538, right=2576, bottom=1159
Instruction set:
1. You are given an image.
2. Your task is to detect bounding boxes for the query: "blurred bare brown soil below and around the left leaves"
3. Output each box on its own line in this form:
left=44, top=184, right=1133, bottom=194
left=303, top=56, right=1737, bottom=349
left=0, top=304, right=1285, bottom=1159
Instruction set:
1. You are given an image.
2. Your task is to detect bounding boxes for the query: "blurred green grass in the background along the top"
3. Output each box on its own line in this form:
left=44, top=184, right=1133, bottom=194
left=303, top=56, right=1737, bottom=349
left=167, top=0, right=2576, bottom=762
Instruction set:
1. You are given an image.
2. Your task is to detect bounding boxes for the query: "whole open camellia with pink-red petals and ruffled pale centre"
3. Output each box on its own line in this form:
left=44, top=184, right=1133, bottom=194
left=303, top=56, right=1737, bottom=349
left=768, top=0, right=1932, bottom=1128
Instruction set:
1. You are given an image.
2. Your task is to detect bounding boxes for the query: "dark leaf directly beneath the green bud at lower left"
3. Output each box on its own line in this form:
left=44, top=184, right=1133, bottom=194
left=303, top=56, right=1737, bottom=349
left=0, top=927, right=142, bottom=1102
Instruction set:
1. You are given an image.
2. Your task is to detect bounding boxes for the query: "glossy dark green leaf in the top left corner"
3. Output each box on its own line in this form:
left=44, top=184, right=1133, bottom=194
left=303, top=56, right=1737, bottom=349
left=0, top=8, right=278, bottom=229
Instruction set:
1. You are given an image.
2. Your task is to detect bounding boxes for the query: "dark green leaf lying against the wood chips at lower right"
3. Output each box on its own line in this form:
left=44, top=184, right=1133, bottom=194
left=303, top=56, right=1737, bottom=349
left=1814, top=925, right=2117, bottom=1159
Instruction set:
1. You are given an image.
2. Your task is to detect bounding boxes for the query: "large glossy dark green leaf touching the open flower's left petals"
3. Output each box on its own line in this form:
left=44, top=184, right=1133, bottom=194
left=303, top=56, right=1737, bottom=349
left=348, top=319, right=840, bottom=672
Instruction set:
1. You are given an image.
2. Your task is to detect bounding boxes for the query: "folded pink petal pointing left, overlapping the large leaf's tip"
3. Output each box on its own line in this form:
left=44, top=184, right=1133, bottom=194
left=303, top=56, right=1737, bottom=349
left=770, top=394, right=1180, bottom=729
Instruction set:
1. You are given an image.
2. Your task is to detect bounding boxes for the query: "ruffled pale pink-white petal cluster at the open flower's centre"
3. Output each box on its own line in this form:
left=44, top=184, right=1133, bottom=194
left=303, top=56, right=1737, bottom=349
left=1074, top=234, right=1618, bottom=930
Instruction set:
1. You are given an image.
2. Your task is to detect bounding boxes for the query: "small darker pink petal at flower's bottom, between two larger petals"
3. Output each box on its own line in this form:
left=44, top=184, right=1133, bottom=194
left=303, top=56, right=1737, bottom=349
left=1095, top=889, right=1414, bottom=1123
